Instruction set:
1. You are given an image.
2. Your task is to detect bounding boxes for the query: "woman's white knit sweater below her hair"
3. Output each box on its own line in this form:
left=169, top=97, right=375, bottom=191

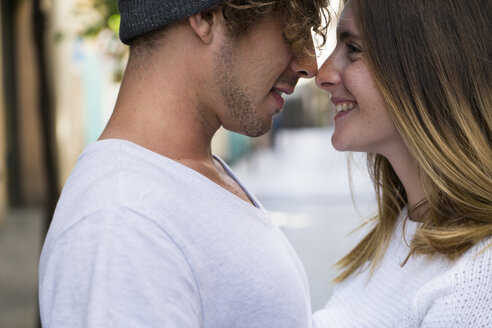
left=313, top=212, right=492, bottom=328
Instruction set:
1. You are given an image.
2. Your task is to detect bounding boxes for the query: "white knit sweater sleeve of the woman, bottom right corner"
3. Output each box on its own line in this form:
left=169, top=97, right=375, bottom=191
left=414, top=238, right=492, bottom=328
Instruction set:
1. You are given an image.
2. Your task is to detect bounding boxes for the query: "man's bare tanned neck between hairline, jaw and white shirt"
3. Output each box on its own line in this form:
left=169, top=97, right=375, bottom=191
left=100, top=53, right=220, bottom=163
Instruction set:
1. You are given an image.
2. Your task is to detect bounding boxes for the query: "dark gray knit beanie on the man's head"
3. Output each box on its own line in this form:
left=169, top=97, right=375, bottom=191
left=118, top=0, right=224, bottom=44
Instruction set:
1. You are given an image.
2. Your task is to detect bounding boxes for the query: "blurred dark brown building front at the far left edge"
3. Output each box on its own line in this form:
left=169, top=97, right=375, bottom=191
left=0, top=1, right=45, bottom=214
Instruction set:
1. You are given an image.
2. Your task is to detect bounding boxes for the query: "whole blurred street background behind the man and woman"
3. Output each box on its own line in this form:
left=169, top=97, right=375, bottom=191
left=0, top=0, right=375, bottom=328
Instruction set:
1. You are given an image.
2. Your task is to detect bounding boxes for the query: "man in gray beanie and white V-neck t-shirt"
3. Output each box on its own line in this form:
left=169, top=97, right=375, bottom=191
left=39, top=0, right=326, bottom=328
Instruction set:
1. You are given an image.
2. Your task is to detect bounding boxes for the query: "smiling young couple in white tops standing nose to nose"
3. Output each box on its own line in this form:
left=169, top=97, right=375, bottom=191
left=39, top=0, right=492, bottom=328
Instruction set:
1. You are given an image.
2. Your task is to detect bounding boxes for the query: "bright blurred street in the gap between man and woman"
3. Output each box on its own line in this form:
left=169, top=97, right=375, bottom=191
left=233, top=127, right=376, bottom=311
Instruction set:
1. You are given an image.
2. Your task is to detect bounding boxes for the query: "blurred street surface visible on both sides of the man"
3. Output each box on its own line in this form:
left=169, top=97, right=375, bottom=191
left=0, top=128, right=374, bottom=328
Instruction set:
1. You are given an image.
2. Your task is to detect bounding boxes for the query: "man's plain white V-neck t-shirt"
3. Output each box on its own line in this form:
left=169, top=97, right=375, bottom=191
left=39, top=140, right=311, bottom=328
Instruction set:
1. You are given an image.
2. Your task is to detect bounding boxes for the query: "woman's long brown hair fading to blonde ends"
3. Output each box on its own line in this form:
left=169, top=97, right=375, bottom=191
left=335, top=0, right=492, bottom=282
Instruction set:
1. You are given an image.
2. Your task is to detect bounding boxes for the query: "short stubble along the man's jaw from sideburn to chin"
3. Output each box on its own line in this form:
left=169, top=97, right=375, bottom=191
left=215, top=41, right=272, bottom=137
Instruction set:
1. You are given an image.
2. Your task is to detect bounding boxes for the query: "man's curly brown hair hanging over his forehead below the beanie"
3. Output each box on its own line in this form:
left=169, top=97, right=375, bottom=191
left=221, top=0, right=330, bottom=56
